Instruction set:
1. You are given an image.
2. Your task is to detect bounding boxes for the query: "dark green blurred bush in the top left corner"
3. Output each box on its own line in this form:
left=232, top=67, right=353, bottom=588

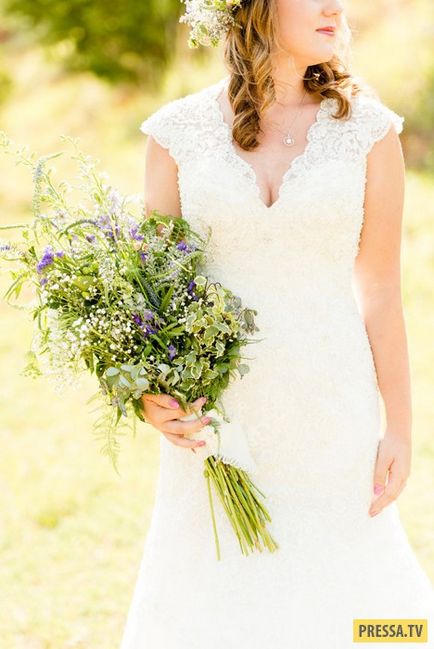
left=3, top=0, right=180, bottom=84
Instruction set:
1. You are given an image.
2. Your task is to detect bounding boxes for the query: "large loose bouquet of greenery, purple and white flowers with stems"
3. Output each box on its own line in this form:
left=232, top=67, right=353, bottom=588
left=0, top=134, right=278, bottom=559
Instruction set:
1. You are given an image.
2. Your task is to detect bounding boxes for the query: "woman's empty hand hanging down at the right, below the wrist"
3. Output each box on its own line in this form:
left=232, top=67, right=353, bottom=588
left=369, top=432, right=411, bottom=516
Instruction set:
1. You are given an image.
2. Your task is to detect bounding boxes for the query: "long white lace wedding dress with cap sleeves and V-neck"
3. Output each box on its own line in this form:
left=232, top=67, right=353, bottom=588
left=121, top=77, right=434, bottom=649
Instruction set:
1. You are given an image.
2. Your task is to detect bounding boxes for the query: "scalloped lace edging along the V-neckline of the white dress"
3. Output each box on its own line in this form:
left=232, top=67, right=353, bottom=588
left=207, top=76, right=333, bottom=212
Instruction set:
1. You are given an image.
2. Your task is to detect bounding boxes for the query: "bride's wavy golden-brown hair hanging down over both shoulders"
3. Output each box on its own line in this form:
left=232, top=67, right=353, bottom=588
left=224, top=0, right=369, bottom=151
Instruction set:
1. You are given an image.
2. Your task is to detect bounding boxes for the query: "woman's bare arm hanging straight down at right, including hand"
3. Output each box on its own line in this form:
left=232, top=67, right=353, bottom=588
left=355, top=121, right=412, bottom=513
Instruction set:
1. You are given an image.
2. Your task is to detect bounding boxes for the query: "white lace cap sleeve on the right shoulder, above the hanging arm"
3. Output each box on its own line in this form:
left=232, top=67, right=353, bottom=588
left=358, top=96, right=405, bottom=153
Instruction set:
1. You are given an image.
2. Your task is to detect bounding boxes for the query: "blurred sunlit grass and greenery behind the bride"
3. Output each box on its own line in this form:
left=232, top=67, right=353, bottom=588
left=0, top=0, right=434, bottom=649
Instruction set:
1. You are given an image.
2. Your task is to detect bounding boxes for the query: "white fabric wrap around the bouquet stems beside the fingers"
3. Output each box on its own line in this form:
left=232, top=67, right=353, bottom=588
left=180, top=408, right=256, bottom=472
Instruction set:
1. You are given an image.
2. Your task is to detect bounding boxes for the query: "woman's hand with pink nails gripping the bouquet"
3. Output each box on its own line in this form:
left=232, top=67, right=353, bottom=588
left=141, top=392, right=211, bottom=453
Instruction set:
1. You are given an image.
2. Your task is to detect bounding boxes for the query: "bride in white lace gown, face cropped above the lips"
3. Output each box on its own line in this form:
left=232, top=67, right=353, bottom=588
left=122, top=0, right=434, bottom=649
